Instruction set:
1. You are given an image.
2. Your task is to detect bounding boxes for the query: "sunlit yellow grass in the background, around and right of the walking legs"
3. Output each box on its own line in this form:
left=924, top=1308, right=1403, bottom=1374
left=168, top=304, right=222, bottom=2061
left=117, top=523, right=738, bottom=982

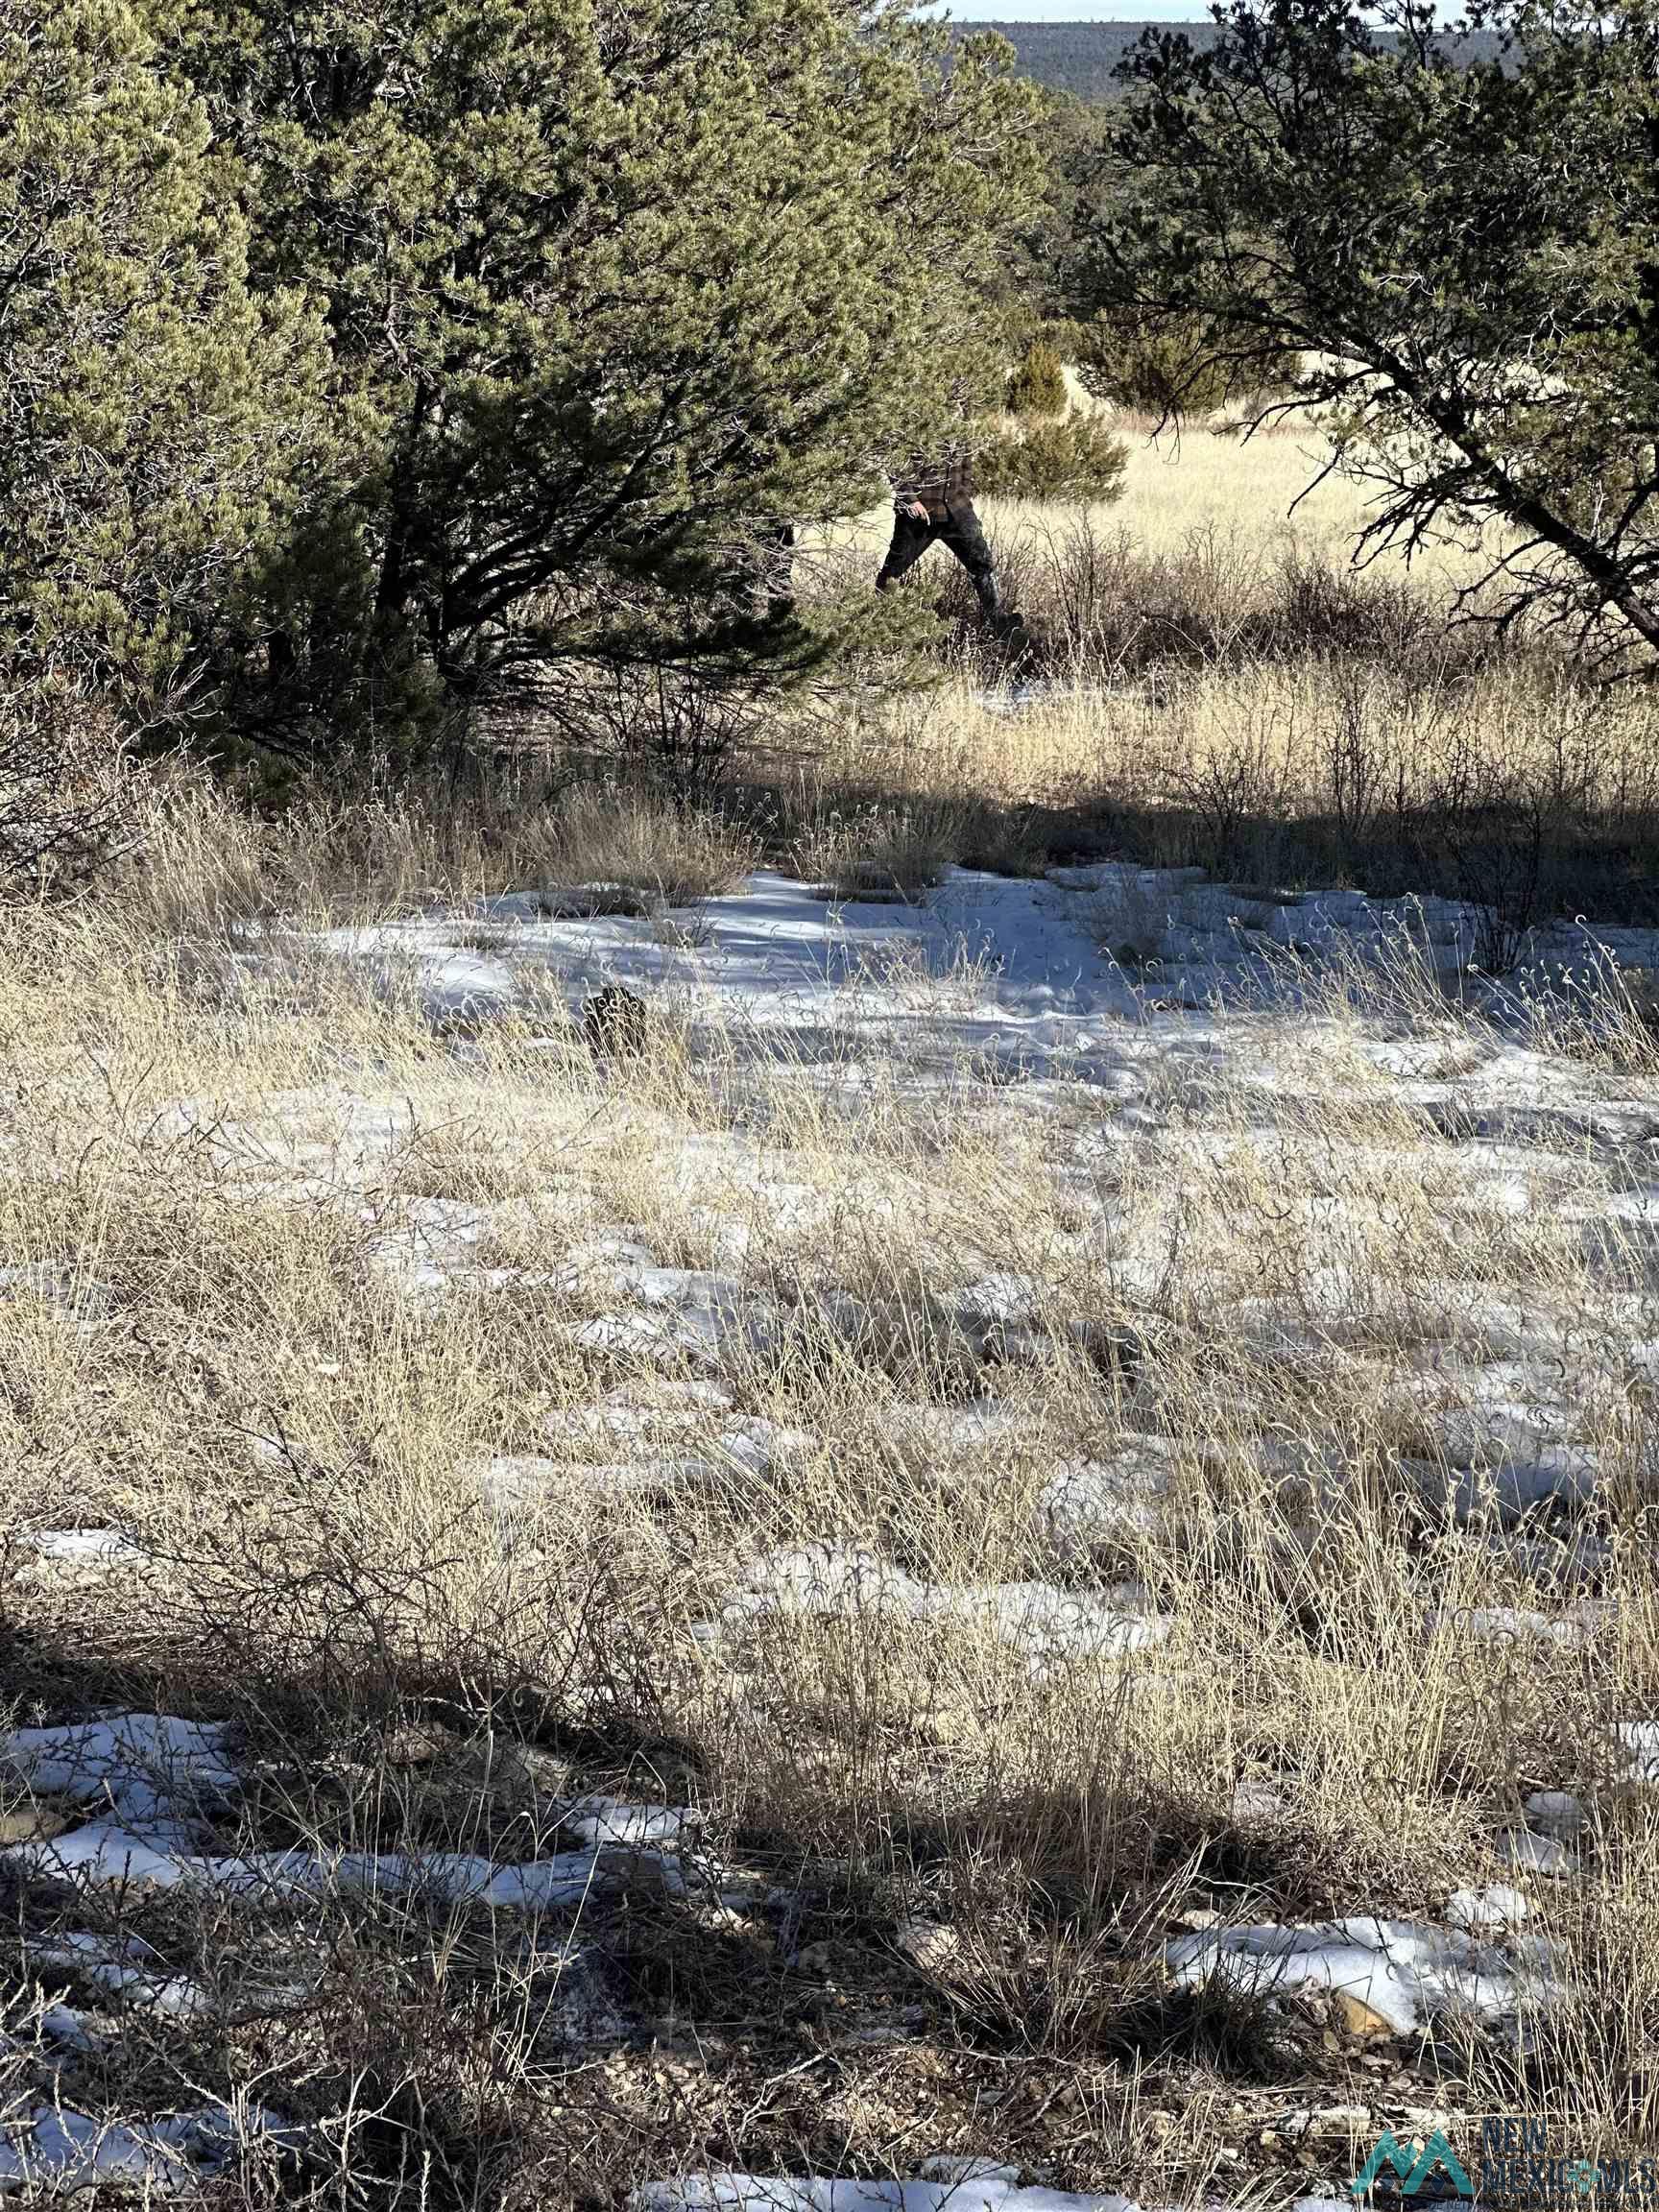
left=791, top=424, right=1659, bottom=933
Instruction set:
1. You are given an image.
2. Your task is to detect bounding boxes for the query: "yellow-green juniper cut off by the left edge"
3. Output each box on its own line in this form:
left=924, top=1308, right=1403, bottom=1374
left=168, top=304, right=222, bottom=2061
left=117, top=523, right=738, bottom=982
left=0, top=0, right=323, bottom=714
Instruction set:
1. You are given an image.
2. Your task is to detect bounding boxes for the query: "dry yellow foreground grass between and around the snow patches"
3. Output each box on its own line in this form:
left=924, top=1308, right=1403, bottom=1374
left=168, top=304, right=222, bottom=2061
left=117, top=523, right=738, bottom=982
left=0, top=779, right=1659, bottom=2205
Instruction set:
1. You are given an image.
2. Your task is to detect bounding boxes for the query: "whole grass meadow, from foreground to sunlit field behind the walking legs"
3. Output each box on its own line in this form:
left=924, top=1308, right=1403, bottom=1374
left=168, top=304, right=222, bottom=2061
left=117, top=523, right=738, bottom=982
left=0, top=431, right=1659, bottom=2212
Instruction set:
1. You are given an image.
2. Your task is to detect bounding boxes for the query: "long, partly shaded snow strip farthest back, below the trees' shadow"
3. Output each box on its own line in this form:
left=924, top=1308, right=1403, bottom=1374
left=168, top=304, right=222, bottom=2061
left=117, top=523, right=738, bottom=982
left=299, top=863, right=1659, bottom=1064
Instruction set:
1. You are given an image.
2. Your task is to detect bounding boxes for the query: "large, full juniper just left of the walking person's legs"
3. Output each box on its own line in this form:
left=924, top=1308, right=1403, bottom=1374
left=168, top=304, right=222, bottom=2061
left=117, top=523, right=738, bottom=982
left=155, top=0, right=1035, bottom=743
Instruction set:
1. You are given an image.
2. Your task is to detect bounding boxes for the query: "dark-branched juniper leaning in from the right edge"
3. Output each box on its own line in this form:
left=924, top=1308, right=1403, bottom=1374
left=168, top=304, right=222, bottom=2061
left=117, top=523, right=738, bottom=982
left=1084, top=0, right=1659, bottom=666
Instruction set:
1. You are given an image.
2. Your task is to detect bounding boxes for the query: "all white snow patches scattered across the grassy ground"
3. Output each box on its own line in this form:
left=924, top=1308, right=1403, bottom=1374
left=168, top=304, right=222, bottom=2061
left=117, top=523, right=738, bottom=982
left=19, top=865, right=1659, bottom=2185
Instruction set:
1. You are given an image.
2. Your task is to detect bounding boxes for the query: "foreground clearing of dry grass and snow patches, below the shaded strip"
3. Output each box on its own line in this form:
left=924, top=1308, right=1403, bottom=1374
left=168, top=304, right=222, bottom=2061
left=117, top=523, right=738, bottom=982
left=0, top=435, right=1659, bottom=2212
